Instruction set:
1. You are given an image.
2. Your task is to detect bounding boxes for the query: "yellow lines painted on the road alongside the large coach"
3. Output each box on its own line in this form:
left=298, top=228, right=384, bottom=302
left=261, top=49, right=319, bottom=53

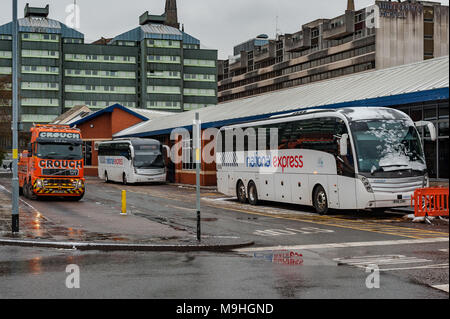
left=202, top=198, right=448, bottom=239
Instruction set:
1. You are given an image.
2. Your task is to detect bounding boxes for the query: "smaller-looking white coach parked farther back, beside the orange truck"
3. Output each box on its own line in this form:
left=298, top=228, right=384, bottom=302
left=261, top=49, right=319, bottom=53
left=98, top=138, right=166, bottom=184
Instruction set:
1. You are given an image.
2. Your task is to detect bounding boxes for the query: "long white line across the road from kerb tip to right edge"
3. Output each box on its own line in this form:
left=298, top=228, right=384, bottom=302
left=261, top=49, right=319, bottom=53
left=234, top=237, right=449, bottom=253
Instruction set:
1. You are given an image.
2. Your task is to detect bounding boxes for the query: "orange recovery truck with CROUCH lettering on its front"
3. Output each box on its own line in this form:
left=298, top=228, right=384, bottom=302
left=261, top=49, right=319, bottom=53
left=19, top=124, right=85, bottom=201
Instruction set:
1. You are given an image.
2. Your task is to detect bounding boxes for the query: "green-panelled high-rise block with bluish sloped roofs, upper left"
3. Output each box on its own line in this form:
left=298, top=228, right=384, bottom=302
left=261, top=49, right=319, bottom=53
left=0, top=0, right=217, bottom=130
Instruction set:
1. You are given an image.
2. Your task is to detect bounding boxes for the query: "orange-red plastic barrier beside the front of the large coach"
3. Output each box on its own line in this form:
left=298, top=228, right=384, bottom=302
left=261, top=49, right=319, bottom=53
left=411, top=187, right=448, bottom=217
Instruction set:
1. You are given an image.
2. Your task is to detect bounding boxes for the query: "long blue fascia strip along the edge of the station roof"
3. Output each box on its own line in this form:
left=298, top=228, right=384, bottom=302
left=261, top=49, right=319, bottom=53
left=120, top=88, right=449, bottom=137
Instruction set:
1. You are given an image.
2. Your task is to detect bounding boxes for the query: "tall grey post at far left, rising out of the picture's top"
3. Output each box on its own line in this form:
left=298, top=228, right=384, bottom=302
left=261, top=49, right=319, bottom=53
left=11, top=0, right=19, bottom=233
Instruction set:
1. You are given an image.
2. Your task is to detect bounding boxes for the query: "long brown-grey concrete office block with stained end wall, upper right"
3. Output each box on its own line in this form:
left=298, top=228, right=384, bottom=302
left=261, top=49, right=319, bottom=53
left=218, top=0, right=449, bottom=103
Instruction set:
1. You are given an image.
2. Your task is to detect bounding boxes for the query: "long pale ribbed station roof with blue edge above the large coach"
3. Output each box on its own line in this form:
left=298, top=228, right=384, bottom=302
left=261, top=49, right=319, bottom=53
left=114, top=56, right=449, bottom=137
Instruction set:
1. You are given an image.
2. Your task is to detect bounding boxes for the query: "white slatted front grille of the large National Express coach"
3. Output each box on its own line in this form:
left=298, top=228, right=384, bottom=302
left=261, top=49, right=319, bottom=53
left=369, top=176, right=424, bottom=193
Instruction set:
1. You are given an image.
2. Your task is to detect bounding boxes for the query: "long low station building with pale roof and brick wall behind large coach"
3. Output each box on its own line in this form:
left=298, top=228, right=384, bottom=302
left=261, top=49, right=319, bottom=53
left=113, top=56, right=449, bottom=186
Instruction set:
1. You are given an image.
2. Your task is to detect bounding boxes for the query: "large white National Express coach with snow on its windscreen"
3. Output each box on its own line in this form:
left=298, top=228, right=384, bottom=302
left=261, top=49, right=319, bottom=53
left=216, top=107, right=436, bottom=214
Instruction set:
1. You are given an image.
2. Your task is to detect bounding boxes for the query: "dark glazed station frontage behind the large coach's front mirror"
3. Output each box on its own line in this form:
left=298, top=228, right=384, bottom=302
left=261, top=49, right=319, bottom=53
left=393, top=100, right=449, bottom=179
